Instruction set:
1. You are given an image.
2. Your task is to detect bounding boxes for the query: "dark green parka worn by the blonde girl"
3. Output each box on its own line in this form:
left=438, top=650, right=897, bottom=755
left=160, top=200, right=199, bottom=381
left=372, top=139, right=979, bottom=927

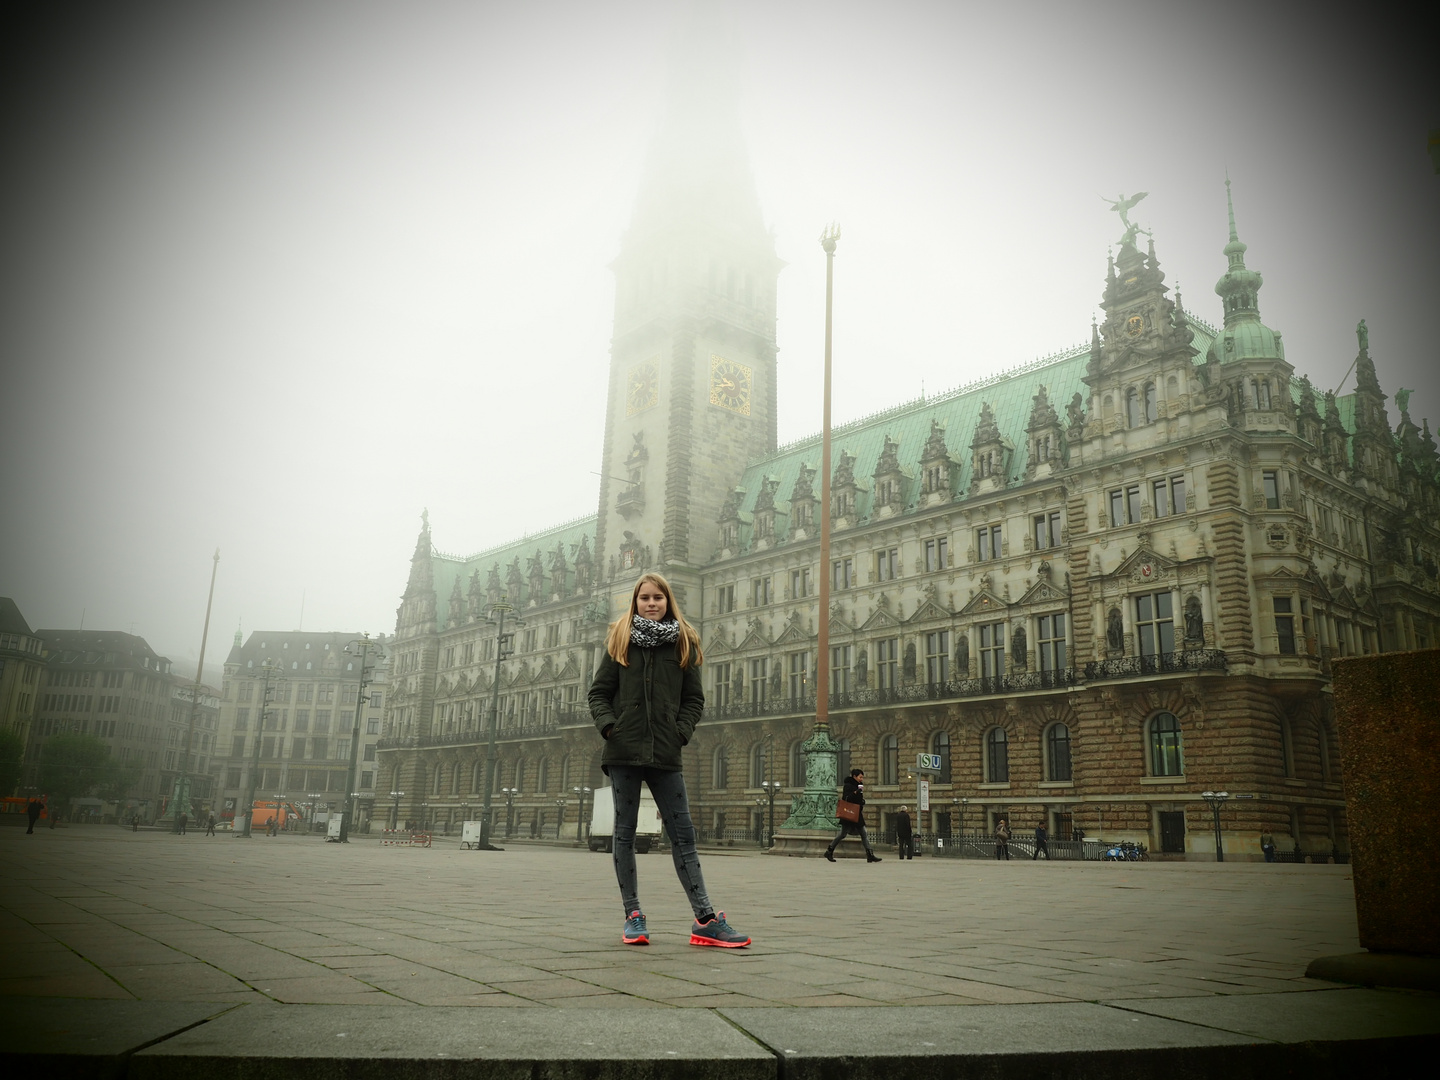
left=589, top=642, right=706, bottom=776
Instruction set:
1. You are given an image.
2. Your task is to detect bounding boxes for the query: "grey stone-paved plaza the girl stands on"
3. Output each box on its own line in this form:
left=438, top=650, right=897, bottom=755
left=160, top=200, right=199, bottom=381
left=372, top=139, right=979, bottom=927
left=0, top=827, right=1440, bottom=1080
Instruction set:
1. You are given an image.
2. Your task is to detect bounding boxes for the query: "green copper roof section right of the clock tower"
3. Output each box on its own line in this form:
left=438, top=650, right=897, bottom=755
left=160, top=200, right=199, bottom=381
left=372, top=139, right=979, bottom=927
left=739, top=318, right=1218, bottom=549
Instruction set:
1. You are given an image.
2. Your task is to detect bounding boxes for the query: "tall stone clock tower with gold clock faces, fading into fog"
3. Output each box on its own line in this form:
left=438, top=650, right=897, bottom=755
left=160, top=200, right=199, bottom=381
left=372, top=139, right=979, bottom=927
left=595, top=76, right=782, bottom=618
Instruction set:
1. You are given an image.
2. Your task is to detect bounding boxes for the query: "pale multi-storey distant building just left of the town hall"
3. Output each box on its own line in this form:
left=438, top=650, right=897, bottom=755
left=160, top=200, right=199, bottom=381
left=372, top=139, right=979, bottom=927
left=213, top=631, right=389, bottom=821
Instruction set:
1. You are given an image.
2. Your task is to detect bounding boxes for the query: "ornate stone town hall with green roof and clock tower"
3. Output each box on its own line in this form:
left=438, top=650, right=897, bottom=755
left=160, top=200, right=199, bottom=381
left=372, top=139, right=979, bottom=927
left=377, top=120, right=1440, bottom=857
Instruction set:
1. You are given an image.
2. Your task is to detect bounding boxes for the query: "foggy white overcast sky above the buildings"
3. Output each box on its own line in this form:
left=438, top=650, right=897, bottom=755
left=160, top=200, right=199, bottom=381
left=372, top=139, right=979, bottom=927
left=0, top=3, right=1440, bottom=676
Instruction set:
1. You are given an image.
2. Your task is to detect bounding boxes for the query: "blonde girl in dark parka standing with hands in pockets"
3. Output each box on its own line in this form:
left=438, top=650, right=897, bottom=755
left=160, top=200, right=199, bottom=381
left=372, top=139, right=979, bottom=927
left=589, top=573, right=750, bottom=949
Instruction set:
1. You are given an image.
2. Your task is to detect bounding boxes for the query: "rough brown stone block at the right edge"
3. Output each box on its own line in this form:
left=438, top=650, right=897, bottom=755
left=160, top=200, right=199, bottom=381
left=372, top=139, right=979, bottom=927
left=1335, top=649, right=1440, bottom=955
